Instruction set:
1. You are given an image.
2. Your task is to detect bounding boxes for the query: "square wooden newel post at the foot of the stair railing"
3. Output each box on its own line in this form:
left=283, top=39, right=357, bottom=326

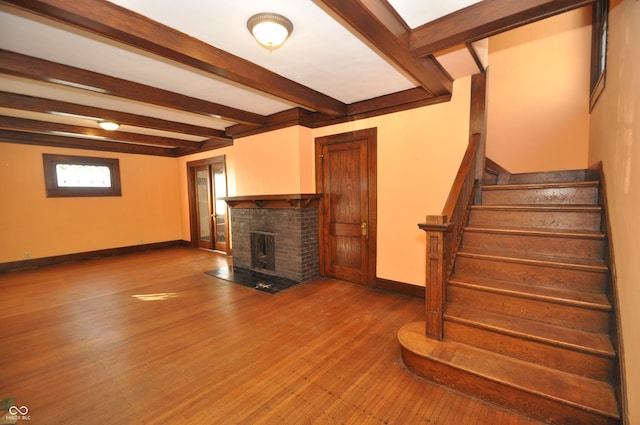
left=418, top=215, right=454, bottom=341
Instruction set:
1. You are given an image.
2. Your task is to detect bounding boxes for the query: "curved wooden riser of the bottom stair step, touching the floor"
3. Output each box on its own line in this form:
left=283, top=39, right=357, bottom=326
left=402, top=348, right=618, bottom=425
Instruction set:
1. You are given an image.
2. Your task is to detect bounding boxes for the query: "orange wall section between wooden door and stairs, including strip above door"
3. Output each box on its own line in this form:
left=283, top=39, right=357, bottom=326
left=313, top=77, right=471, bottom=286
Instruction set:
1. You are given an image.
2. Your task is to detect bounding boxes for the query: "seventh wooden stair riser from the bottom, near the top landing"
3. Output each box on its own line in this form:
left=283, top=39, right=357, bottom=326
left=482, top=186, right=598, bottom=205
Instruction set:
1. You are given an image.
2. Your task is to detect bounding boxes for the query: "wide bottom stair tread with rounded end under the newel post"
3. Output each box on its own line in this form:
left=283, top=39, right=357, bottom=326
left=398, top=322, right=619, bottom=419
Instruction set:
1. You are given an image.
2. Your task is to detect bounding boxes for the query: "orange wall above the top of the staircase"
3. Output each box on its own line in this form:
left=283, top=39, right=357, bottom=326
left=487, top=7, right=591, bottom=173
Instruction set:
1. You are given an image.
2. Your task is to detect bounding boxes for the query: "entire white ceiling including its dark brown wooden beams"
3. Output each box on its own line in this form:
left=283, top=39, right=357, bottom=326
left=0, top=0, right=594, bottom=157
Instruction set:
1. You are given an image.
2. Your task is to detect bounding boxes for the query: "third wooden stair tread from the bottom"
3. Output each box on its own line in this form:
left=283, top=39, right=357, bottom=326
left=449, top=272, right=611, bottom=311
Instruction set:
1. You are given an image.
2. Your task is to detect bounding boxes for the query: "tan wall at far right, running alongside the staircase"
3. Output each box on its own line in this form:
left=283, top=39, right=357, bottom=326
left=589, top=0, right=640, bottom=424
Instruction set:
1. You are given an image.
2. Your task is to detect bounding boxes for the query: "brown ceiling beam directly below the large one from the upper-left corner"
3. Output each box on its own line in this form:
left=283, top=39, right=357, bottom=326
left=0, top=49, right=266, bottom=126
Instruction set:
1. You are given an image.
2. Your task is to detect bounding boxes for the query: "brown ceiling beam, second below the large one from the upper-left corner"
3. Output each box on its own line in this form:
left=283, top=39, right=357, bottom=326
left=0, top=91, right=229, bottom=139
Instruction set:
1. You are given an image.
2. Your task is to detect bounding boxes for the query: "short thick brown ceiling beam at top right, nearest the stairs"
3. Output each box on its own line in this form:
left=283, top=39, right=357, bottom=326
left=409, top=0, right=597, bottom=57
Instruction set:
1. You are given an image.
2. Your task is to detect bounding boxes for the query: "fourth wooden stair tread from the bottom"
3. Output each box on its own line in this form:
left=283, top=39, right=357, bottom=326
left=458, top=248, right=608, bottom=273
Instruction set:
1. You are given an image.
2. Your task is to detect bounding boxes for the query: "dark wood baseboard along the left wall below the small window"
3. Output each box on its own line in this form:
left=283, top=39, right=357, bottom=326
left=0, top=240, right=189, bottom=273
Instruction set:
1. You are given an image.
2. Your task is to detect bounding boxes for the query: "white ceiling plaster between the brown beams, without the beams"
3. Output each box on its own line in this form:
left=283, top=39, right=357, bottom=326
left=0, top=0, right=478, bottom=142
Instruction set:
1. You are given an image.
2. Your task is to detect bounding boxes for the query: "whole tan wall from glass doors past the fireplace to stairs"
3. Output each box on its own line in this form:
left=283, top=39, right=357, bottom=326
left=179, top=78, right=471, bottom=286
